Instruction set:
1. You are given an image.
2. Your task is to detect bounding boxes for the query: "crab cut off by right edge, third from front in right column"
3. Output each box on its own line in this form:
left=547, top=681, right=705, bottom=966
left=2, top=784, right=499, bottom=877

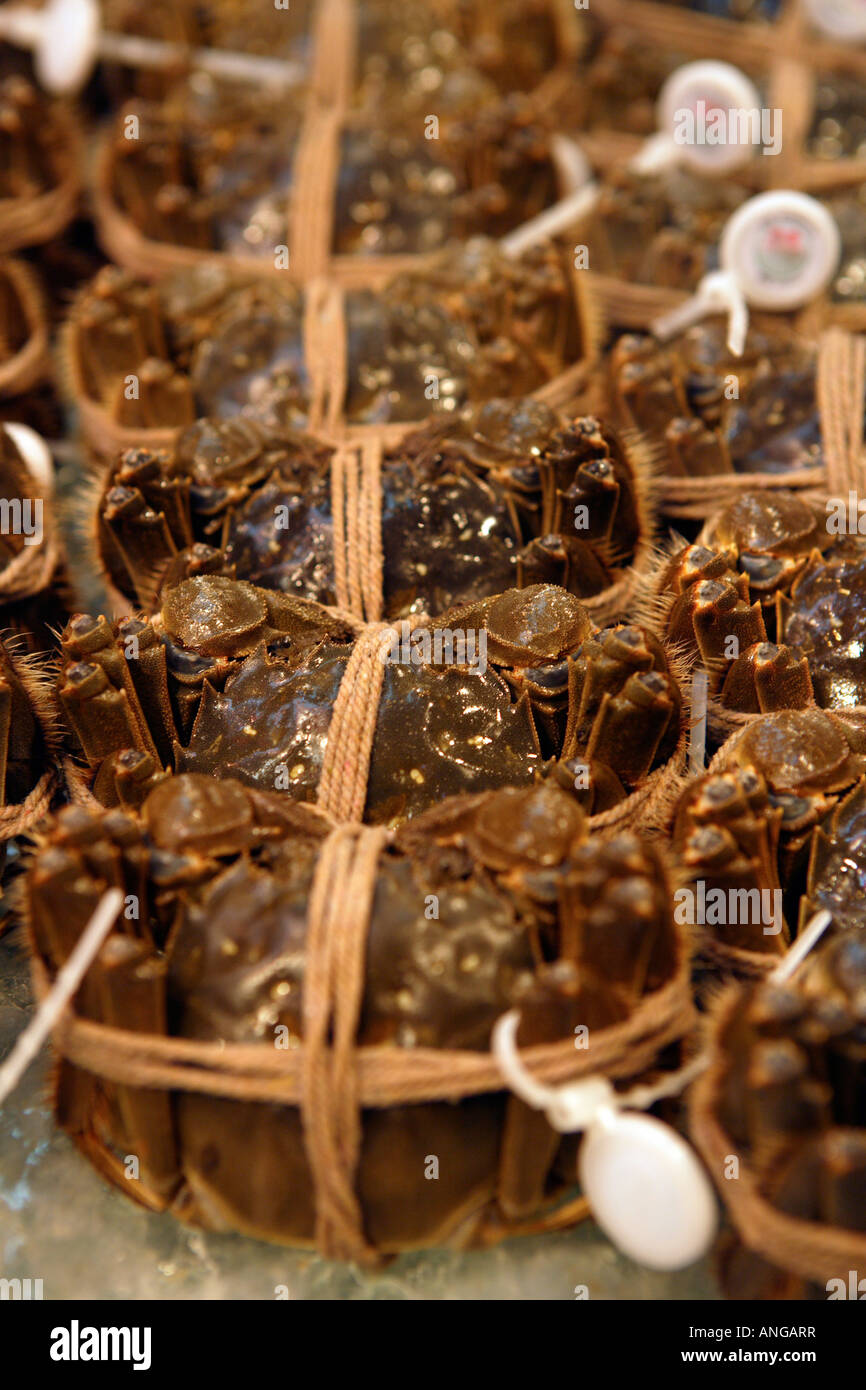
left=644, top=491, right=866, bottom=714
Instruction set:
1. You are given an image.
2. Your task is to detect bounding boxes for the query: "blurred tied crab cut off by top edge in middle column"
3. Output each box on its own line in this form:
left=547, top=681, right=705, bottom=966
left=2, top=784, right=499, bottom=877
left=97, top=0, right=581, bottom=113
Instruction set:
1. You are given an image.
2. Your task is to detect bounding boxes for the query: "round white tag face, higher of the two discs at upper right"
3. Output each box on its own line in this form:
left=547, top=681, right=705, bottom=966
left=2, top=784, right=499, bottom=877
left=657, top=63, right=763, bottom=174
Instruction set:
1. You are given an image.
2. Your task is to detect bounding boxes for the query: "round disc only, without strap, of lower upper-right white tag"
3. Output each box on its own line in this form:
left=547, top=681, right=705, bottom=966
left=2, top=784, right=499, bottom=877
left=719, top=190, right=841, bottom=311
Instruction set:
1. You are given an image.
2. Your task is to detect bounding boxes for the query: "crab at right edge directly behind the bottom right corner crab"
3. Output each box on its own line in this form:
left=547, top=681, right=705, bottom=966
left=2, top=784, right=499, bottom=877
left=671, top=709, right=866, bottom=976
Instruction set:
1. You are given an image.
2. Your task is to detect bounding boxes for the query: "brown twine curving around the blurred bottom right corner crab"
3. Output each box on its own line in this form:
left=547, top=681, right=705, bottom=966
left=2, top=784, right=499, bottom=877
left=689, top=990, right=866, bottom=1283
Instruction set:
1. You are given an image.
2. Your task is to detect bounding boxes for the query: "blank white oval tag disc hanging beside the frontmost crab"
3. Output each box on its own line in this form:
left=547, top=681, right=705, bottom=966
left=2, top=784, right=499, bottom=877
left=578, top=1109, right=717, bottom=1269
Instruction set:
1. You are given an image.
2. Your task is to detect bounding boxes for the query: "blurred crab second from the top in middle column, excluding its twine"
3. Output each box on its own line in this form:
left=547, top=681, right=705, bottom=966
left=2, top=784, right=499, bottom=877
left=106, top=83, right=557, bottom=265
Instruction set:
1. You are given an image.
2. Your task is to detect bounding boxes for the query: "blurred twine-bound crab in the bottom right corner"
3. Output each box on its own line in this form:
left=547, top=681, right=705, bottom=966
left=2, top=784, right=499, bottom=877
left=691, top=928, right=866, bottom=1300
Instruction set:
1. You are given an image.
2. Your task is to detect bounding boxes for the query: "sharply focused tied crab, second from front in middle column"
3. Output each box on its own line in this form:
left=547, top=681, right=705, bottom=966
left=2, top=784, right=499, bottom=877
left=57, top=574, right=687, bottom=827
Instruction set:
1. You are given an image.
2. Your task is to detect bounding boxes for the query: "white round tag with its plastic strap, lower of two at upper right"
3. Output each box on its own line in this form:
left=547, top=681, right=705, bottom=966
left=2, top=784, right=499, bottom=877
left=652, top=189, right=842, bottom=357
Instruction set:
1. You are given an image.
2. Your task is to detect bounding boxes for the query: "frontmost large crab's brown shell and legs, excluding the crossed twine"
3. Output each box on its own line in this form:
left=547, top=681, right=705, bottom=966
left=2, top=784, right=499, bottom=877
left=26, top=776, right=683, bottom=1252
